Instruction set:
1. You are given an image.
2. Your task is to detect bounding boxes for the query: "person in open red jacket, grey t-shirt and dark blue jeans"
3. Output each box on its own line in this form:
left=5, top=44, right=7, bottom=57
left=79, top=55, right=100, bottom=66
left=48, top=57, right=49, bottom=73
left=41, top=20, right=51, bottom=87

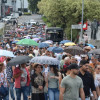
left=13, top=63, right=30, bottom=100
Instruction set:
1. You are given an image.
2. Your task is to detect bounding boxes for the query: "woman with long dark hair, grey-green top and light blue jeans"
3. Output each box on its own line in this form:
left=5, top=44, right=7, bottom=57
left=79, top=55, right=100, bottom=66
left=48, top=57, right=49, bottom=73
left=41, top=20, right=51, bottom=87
left=46, top=65, right=60, bottom=100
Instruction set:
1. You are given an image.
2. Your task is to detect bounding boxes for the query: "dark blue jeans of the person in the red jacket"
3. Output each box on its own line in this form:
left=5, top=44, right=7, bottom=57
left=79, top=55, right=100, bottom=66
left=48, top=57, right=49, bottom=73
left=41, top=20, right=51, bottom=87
left=15, top=86, right=28, bottom=100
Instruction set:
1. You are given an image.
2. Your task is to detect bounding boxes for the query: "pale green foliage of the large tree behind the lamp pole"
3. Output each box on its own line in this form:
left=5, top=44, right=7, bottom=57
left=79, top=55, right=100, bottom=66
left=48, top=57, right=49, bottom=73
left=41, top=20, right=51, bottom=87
left=37, top=0, right=100, bottom=40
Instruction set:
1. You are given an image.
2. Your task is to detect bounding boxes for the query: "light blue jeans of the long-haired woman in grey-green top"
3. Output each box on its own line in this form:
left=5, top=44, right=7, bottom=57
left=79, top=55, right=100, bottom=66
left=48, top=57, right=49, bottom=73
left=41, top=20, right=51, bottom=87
left=48, top=88, right=59, bottom=100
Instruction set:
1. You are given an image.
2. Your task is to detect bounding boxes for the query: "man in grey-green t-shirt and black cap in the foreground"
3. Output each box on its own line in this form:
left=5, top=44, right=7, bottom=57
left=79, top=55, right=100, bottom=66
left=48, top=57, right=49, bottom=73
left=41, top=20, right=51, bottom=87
left=59, top=63, right=85, bottom=100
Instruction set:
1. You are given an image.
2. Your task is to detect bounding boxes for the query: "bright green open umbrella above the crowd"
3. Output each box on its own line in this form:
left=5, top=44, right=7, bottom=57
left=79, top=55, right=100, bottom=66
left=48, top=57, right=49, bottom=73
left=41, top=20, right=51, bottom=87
left=16, top=39, right=38, bottom=46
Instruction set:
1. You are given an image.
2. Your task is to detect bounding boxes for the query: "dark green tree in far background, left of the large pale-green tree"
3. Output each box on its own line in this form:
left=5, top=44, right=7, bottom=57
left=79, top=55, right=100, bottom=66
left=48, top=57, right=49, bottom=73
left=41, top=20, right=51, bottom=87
left=28, top=0, right=40, bottom=12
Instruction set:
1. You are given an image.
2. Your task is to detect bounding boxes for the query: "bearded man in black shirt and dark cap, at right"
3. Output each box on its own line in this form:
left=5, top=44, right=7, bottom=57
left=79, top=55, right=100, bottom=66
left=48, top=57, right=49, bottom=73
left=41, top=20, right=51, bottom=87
left=78, top=60, right=97, bottom=100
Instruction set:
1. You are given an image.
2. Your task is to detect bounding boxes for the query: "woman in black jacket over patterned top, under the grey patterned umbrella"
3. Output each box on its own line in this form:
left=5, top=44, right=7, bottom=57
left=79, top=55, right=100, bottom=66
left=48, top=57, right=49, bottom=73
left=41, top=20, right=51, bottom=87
left=31, top=64, right=45, bottom=100
